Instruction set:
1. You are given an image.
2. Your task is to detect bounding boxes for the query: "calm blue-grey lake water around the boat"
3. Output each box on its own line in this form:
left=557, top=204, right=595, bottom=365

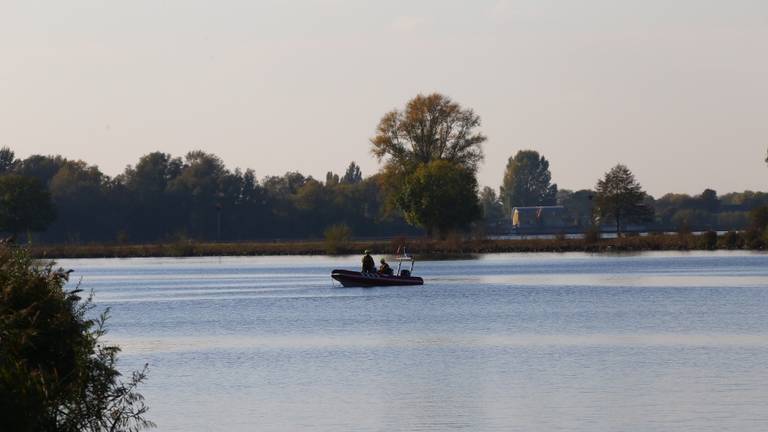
left=61, top=252, right=768, bottom=432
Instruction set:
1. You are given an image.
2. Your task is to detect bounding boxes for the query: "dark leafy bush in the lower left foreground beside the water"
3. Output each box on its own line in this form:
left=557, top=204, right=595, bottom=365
left=0, top=245, right=154, bottom=432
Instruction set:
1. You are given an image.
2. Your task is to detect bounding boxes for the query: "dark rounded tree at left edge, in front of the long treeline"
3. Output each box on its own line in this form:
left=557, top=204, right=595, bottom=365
left=0, top=174, right=56, bottom=235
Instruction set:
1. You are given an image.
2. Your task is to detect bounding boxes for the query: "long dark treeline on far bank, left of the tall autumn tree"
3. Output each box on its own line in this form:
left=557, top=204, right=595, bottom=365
left=0, top=148, right=419, bottom=243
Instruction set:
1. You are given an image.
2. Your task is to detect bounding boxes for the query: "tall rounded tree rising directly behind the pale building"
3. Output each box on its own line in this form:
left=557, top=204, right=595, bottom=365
left=501, top=150, right=557, bottom=215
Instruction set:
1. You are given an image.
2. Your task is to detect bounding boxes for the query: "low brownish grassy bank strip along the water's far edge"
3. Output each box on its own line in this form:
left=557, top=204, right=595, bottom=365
left=25, top=233, right=763, bottom=258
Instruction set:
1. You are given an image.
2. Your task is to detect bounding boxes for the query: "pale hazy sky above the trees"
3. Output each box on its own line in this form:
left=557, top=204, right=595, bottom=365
left=0, top=0, right=768, bottom=196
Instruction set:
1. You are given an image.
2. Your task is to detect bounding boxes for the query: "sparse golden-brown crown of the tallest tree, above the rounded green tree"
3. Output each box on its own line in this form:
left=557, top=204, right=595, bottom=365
left=371, top=93, right=486, bottom=173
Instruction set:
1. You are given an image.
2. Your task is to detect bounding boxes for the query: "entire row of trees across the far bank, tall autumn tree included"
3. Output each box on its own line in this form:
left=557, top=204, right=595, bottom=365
left=0, top=93, right=768, bottom=243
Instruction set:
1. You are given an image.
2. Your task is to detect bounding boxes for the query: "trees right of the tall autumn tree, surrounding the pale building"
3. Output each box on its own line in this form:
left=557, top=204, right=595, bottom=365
left=480, top=150, right=768, bottom=235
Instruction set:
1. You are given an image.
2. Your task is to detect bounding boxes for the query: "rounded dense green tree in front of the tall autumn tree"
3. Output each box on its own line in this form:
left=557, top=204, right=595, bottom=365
left=397, top=160, right=481, bottom=237
